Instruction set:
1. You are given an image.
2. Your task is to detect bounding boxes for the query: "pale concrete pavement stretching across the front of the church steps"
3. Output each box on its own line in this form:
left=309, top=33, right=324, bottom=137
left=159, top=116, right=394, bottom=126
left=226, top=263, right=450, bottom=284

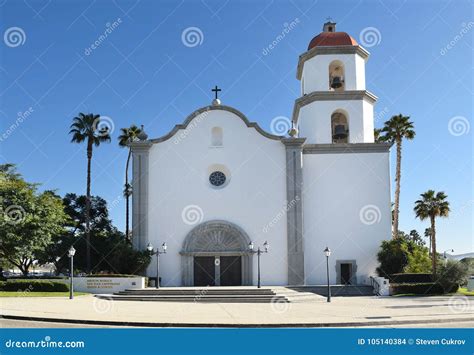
left=0, top=295, right=474, bottom=327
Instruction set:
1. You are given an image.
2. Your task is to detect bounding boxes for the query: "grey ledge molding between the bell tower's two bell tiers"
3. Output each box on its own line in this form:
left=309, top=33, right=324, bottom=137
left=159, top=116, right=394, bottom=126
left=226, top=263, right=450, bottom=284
left=292, top=90, right=378, bottom=123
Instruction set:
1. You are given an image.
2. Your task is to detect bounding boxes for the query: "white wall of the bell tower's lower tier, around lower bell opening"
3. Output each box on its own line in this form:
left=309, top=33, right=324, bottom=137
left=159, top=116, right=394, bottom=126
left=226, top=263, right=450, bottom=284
left=298, top=100, right=374, bottom=144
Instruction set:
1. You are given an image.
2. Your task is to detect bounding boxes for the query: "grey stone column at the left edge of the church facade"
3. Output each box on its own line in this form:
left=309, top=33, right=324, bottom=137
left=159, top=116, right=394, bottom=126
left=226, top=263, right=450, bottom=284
left=131, top=141, right=153, bottom=250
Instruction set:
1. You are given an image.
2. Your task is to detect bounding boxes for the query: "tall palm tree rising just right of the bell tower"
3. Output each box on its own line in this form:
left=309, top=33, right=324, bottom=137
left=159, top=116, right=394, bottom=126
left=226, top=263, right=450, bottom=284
left=377, top=114, right=415, bottom=238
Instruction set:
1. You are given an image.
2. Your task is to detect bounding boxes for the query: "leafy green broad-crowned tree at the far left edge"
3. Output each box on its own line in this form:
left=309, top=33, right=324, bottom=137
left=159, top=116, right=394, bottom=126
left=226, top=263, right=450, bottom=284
left=0, top=166, right=67, bottom=276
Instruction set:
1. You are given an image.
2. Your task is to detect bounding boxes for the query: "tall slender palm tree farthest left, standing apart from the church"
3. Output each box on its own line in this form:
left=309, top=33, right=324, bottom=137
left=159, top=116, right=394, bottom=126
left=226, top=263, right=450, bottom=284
left=69, top=113, right=110, bottom=272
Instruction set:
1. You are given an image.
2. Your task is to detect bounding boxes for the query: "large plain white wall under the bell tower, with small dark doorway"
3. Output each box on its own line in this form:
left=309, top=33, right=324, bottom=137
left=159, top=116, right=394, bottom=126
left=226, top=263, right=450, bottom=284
left=303, top=153, right=391, bottom=284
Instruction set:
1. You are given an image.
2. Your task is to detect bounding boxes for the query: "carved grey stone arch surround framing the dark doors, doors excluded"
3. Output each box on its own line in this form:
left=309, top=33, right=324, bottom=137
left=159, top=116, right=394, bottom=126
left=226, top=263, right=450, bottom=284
left=180, top=220, right=253, bottom=286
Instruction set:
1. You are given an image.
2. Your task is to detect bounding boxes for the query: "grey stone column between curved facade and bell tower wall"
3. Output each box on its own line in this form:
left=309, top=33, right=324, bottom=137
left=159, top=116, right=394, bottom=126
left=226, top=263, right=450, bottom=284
left=282, top=138, right=306, bottom=285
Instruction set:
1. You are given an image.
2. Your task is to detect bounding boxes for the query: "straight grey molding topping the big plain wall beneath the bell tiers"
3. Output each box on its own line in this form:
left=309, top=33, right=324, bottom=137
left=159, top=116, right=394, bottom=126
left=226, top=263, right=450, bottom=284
left=303, top=143, right=392, bottom=154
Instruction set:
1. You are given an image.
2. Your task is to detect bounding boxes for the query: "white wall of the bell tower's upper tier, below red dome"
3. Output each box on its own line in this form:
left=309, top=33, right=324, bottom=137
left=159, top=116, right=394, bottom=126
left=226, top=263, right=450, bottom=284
left=301, top=54, right=365, bottom=95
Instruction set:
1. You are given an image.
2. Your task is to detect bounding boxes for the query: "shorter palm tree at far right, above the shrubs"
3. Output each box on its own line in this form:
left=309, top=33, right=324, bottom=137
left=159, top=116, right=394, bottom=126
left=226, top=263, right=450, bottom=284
left=414, top=190, right=449, bottom=275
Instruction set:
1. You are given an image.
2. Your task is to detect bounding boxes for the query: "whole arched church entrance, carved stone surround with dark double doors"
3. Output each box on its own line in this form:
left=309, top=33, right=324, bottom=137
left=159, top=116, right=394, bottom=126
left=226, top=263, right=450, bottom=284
left=180, top=221, right=252, bottom=286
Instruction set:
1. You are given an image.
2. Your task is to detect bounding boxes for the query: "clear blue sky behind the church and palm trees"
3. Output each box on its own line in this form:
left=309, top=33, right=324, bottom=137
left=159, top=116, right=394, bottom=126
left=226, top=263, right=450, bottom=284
left=0, top=0, right=474, bottom=253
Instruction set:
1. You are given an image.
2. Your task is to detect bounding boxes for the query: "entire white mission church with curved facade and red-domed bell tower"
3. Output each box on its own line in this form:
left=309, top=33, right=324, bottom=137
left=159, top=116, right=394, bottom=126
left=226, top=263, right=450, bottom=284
left=132, top=22, right=391, bottom=286
